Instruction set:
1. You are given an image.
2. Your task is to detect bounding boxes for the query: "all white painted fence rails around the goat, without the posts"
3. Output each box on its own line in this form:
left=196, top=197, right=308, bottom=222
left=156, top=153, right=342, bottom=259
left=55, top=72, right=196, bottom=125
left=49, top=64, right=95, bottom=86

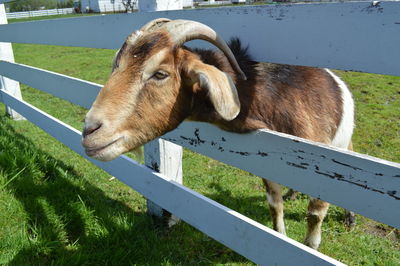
left=0, top=2, right=400, bottom=265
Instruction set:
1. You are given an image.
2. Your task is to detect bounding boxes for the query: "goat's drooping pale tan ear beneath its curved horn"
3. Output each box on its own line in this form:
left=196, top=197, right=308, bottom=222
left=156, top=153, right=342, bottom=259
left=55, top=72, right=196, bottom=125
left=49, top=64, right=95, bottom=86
left=189, top=60, right=240, bottom=121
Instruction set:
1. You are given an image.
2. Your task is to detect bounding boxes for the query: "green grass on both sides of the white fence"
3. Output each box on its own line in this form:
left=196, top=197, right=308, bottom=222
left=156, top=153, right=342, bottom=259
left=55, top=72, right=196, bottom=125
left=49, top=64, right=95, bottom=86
left=0, top=15, right=400, bottom=265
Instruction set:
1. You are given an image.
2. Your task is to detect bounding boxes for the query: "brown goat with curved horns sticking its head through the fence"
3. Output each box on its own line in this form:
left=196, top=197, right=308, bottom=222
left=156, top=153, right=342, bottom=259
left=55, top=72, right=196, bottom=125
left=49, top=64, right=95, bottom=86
left=82, top=19, right=354, bottom=249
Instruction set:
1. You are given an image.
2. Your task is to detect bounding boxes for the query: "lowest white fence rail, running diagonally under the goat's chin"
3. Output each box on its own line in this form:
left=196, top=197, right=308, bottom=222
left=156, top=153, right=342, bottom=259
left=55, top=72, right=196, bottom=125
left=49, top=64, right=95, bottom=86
left=0, top=90, right=343, bottom=265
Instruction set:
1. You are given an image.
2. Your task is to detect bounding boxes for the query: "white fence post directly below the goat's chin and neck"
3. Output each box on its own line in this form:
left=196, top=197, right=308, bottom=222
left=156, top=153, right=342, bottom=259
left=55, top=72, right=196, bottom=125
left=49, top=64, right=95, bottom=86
left=144, top=139, right=183, bottom=227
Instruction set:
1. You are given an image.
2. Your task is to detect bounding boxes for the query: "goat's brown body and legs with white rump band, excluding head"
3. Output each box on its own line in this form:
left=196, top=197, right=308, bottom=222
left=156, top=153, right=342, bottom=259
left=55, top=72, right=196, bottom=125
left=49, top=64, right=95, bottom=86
left=190, top=39, right=354, bottom=249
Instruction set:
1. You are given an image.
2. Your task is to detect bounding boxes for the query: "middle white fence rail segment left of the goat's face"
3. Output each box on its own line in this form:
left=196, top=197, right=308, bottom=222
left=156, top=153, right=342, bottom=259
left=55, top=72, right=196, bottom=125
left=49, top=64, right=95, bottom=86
left=0, top=61, right=102, bottom=109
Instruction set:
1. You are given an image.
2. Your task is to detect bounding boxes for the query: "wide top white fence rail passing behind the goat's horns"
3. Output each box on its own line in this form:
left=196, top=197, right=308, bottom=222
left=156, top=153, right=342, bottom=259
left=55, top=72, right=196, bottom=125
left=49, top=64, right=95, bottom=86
left=0, top=1, right=400, bottom=75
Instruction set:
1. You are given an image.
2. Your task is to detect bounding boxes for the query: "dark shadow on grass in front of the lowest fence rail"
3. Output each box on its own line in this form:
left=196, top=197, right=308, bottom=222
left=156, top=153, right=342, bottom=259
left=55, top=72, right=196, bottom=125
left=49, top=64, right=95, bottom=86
left=0, top=117, right=247, bottom=265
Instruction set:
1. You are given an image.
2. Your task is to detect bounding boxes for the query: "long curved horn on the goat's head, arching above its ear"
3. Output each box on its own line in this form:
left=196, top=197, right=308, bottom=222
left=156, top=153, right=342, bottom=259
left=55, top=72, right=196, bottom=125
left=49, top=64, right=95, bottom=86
left=161, top=19, right=247, bottom=80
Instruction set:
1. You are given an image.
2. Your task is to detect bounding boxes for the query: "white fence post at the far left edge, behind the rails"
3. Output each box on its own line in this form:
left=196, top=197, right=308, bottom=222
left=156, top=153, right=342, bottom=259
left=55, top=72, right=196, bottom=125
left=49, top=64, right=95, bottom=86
left=0, top=4, right=24, bottom=120
